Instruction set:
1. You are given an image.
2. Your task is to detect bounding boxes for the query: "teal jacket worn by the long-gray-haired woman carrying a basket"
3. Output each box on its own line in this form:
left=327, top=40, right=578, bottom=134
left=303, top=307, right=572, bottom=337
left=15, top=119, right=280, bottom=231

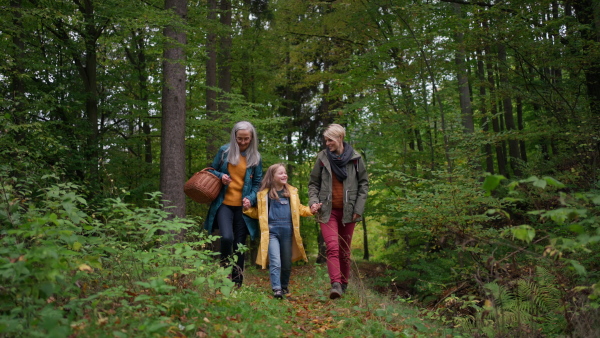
left=204, top=144, right=262, bottom=239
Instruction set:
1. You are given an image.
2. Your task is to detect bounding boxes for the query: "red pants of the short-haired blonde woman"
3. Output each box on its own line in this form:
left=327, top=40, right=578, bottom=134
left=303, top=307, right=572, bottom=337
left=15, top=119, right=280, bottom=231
left=321, top=209, right=356, bottom=284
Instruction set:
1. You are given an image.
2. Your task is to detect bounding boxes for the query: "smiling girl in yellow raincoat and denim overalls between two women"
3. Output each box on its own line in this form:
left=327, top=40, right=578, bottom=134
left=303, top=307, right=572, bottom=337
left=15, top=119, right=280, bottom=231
left=244, top=163, right=322, bottom=299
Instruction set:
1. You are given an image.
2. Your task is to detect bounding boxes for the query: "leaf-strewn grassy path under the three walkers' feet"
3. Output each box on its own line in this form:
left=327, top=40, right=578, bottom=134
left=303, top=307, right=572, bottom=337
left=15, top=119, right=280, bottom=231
left=190, top=262, right=460, bottom=337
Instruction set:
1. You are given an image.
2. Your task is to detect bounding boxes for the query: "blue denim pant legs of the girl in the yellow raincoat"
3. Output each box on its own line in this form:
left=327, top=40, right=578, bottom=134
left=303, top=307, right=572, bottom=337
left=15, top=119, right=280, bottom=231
left=269, top=223, right=292, bottom=290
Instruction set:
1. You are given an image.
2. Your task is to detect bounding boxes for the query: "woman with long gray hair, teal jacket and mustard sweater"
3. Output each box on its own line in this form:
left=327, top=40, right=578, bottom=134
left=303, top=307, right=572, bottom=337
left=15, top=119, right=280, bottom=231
left=204, top=121, right=262, bottom=287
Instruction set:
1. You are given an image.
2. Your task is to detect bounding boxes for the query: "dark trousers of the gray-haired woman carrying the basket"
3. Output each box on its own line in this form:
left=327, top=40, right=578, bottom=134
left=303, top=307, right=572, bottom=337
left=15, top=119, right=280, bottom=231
left=217, top=204, right=248, bottom=284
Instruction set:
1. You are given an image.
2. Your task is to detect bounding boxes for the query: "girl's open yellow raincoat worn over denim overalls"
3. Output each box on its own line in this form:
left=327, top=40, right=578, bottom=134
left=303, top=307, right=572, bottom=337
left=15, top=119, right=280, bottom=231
left=244, top=184, right=312, bottom=269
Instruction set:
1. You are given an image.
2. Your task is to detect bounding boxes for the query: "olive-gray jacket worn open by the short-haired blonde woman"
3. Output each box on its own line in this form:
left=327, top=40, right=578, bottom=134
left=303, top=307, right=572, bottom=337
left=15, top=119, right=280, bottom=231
left=308, top=149, right=369, bottom=223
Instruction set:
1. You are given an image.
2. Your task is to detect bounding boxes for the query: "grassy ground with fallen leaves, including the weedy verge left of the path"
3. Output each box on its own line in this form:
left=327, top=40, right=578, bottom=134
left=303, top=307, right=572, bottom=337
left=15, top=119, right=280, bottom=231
left=72, top=264, right=453, bottom=337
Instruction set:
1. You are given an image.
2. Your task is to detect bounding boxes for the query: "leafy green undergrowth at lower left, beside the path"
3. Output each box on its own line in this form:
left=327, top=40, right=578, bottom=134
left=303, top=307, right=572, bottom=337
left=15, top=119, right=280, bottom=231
left=0, top=171, right=233, bottom=336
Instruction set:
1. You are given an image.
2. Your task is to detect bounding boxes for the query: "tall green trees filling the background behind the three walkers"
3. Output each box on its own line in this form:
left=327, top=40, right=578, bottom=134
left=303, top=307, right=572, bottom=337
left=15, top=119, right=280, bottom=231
left=0, top=0, right=600, bottom=336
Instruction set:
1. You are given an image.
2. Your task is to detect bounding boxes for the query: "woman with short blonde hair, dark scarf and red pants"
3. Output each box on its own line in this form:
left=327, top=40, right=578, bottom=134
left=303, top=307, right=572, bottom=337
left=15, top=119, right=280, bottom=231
left=308, top=124, right=369, bottom=299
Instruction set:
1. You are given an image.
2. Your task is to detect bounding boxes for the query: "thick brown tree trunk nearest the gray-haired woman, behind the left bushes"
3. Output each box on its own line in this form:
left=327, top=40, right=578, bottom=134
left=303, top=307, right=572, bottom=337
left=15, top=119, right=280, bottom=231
left=160, top=0, right=187, bottom=222
